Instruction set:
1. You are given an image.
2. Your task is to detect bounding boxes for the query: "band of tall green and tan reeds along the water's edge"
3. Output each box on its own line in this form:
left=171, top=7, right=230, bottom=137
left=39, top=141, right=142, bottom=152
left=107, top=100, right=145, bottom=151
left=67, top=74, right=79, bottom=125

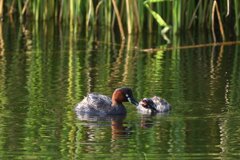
left=0, top=0, right=240, bottom=39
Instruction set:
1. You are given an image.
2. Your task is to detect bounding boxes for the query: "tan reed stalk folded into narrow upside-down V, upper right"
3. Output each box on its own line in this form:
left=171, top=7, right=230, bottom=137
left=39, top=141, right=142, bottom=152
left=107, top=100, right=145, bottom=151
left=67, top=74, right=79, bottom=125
left=212, top=0, right=225, bottom=42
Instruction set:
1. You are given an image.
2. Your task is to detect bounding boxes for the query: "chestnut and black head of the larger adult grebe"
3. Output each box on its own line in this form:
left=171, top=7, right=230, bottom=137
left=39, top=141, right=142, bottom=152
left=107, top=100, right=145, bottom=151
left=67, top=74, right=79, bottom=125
left=112, top=87, right=138, bottom=106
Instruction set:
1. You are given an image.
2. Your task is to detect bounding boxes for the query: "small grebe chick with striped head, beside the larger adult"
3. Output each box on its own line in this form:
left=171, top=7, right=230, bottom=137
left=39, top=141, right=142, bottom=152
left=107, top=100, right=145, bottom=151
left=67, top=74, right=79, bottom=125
left=137, top=96, right=171, bottom=113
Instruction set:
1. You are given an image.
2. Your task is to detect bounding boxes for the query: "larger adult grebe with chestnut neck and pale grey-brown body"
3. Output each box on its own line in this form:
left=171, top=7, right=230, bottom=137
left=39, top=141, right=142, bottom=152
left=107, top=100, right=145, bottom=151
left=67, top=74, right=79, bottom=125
left=75, top=87, right=138, bottom=115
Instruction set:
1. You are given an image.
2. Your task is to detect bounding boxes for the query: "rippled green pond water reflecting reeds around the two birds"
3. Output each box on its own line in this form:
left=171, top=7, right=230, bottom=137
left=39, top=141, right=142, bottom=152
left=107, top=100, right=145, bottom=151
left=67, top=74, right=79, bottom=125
left=0, top=21, right=240, bottom=159
